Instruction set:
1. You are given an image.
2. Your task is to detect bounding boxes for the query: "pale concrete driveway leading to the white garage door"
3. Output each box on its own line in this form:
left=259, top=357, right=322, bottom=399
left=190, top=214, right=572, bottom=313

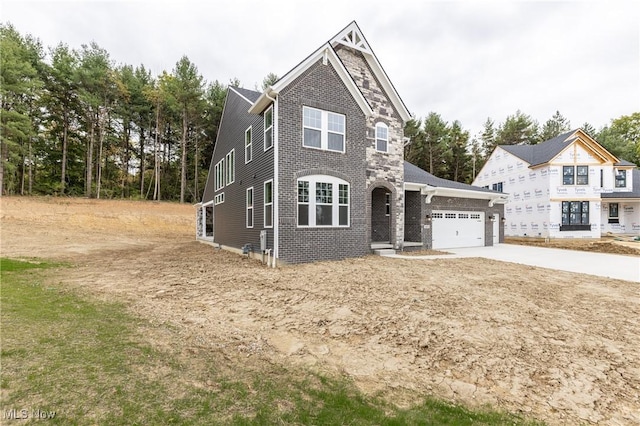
left=445, top=244, right=640, bottom=282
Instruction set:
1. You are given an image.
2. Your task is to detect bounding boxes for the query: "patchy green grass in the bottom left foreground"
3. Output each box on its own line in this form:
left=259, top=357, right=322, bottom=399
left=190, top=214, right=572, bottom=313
left=0, top=259, right=537, bottom=425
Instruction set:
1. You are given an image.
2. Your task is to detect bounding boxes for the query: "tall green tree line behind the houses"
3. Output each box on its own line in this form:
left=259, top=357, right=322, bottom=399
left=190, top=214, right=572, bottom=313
left=0, top=24, right=640, bottom=202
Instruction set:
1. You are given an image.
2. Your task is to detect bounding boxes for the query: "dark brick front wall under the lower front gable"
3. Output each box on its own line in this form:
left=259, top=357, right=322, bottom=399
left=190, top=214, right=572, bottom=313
left=278, top=56, right=370, bottom=263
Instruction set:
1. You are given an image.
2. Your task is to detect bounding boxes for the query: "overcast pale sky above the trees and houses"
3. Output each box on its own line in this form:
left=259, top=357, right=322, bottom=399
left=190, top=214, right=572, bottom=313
left=0, top=0, right=640, bottom=137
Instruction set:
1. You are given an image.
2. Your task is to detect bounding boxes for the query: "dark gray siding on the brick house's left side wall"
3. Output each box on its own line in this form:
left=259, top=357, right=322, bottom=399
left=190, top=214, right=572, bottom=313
left=207, top=89, right=273, bottom=252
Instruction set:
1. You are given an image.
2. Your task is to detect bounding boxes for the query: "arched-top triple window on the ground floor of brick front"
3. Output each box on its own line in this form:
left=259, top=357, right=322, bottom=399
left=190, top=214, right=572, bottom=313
left=298, top=175, right=350, bottom=227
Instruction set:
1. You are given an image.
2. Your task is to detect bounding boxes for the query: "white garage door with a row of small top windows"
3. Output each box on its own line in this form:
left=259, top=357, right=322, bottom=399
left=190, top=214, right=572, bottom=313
left=431, top=210, right=484, bottom=249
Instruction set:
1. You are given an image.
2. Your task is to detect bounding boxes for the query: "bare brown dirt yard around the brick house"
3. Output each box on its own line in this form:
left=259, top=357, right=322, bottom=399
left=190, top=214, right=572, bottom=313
left=0, top=197, right=640, bottom=425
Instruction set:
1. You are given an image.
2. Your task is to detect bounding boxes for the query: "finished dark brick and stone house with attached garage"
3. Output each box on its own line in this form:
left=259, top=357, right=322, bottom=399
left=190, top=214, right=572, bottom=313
left=196, top=22, right=505, bottom=265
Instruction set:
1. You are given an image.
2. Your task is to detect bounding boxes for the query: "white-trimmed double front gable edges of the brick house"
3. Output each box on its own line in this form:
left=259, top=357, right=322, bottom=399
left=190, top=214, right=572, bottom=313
left=249, top=21, right=411, bottom=122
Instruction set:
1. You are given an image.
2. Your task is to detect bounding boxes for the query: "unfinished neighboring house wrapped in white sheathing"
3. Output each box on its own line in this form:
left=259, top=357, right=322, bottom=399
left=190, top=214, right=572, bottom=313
left=473, top=129, right=640, bottom=238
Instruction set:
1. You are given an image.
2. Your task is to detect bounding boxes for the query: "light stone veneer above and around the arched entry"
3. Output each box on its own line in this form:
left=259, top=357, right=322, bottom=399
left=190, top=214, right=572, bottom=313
left=336, top=46, right=404, bottom=249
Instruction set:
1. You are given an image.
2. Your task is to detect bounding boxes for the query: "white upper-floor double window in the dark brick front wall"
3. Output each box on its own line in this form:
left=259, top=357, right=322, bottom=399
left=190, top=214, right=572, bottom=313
left=302, top=107, right=345, bottom=152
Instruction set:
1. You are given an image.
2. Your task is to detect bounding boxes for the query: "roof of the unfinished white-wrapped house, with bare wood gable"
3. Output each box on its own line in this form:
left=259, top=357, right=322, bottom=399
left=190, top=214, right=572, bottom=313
left=499, top=129, right=620, bottom=167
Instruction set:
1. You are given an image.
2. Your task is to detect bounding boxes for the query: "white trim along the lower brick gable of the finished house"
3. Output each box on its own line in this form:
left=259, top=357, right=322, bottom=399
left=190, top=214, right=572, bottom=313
left=249, top=43, right=373, bottom=117
